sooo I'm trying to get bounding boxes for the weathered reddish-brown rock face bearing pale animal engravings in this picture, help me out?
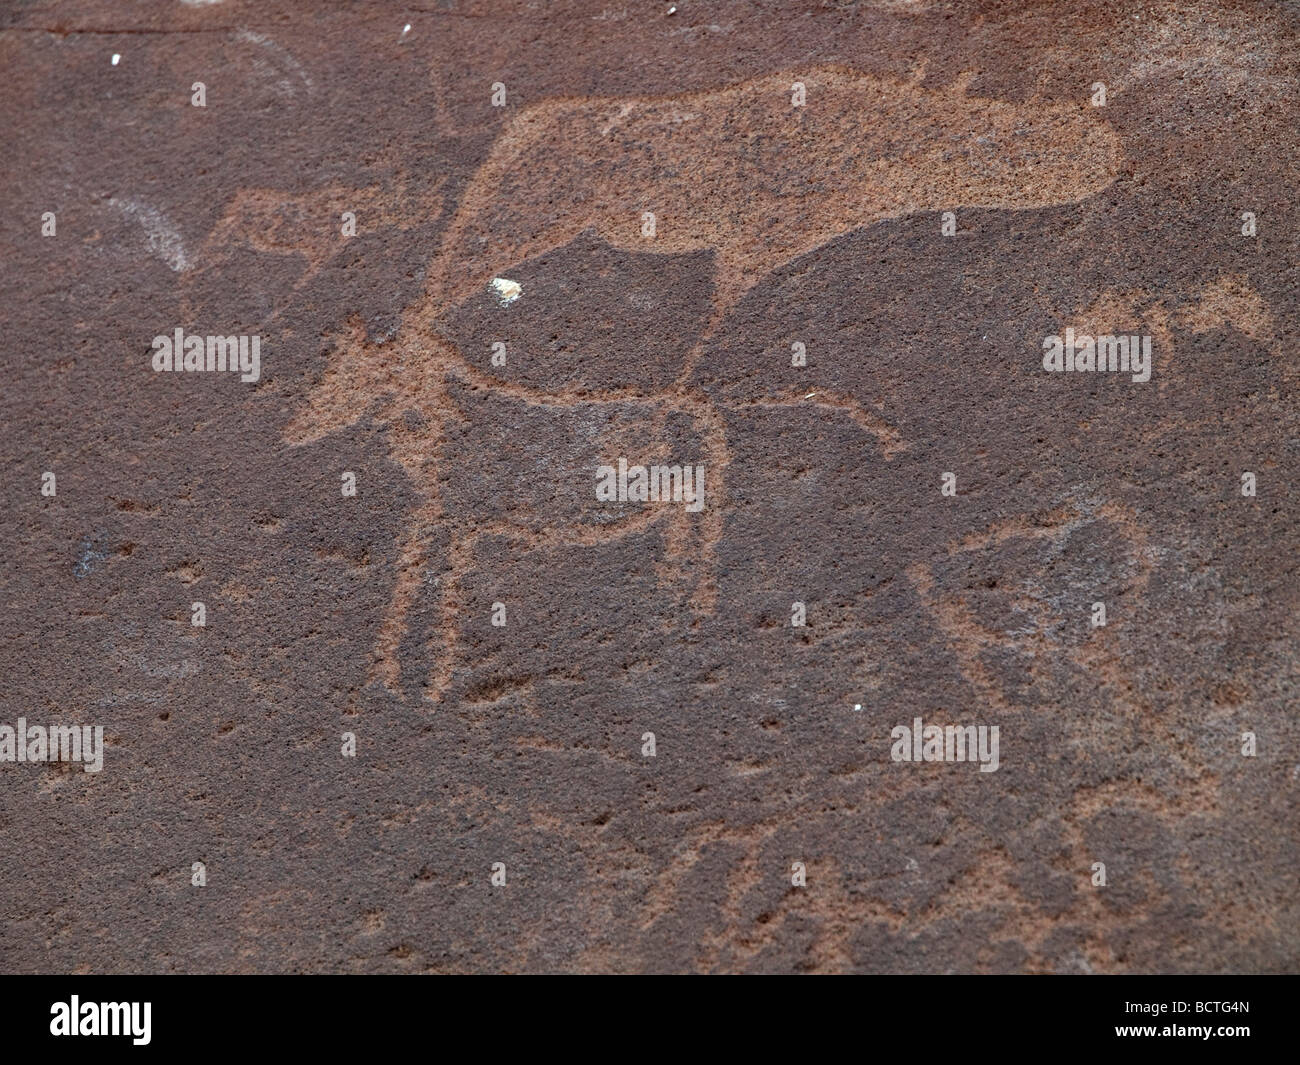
[0,0,1300,973]
